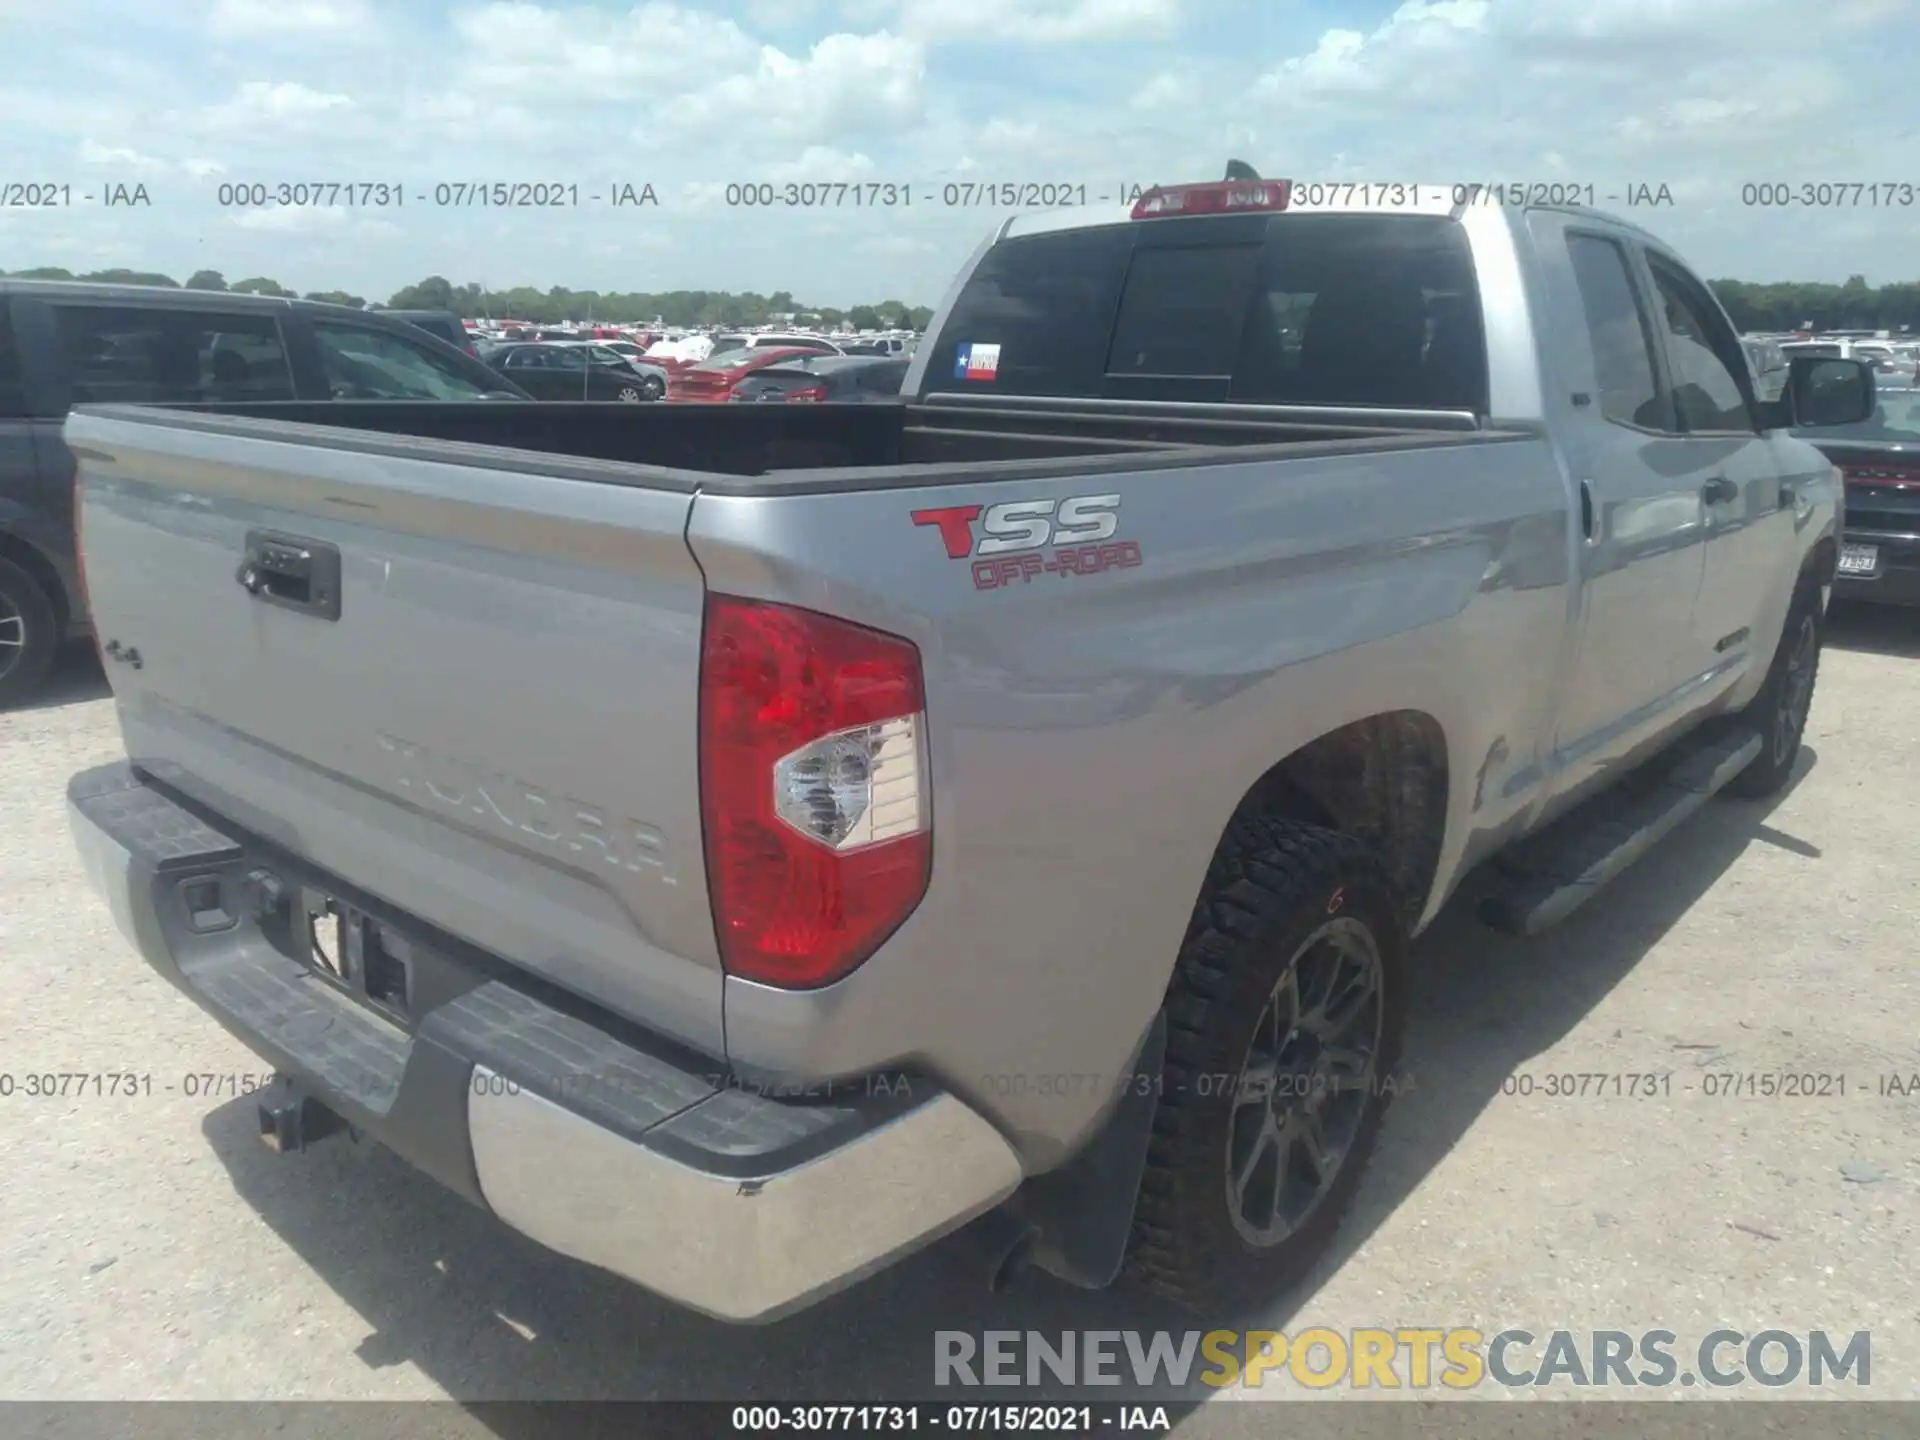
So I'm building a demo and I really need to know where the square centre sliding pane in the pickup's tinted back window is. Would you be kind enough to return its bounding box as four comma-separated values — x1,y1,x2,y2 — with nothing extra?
1106,246,1260,378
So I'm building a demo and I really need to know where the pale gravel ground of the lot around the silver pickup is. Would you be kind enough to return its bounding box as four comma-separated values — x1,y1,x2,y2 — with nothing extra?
0,612,1920,1440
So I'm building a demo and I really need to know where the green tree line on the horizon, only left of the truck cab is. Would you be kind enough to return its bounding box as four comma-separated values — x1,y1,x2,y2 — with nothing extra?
0,265,933,330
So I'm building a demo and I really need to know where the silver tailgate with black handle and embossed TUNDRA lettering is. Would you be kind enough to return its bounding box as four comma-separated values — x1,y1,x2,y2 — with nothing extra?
65,411,724,1056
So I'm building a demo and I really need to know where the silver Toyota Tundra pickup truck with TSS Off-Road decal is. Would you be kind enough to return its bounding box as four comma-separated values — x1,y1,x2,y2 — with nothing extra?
65,180,1872,1321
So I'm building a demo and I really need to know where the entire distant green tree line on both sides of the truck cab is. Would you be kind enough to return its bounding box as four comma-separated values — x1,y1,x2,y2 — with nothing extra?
12,265,1920,330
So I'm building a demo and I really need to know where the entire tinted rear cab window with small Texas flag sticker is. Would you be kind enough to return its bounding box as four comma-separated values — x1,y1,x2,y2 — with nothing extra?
925,213,1488,413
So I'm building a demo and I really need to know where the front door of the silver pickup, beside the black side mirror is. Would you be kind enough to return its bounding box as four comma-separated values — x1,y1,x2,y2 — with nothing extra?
1645,248,1795,687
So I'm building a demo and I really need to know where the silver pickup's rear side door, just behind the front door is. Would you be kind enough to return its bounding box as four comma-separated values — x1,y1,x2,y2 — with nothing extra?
1526,211,1705,793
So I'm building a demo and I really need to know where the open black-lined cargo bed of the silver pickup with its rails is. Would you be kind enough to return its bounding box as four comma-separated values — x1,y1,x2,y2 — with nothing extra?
77,397,1501,495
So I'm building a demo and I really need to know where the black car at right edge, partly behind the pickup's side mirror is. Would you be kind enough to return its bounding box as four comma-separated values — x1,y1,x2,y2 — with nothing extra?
1795,378,1920,605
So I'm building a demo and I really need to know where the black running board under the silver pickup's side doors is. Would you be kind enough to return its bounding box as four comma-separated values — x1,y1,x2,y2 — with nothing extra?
1478,730,1761,935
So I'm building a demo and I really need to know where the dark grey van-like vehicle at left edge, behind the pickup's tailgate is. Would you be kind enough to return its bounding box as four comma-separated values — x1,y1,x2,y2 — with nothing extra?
0,280,530,707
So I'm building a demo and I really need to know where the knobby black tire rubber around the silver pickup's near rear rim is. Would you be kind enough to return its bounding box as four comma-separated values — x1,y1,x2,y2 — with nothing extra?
1125,816,1407,1313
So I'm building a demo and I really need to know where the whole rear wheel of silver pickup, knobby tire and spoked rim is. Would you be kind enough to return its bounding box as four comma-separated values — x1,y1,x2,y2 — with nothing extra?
1127,818,1405,1308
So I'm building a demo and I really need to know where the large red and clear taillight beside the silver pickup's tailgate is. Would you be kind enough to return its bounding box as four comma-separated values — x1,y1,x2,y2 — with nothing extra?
699,595,933,989
